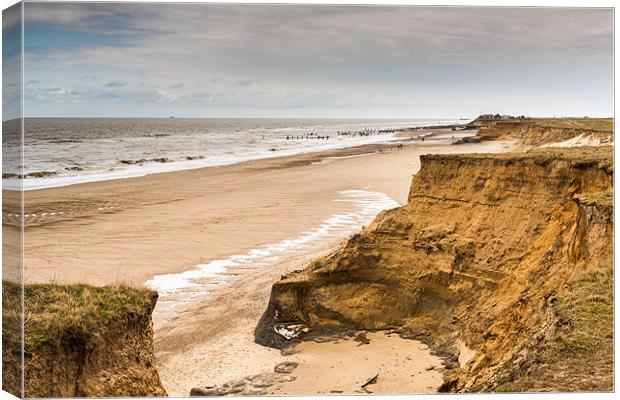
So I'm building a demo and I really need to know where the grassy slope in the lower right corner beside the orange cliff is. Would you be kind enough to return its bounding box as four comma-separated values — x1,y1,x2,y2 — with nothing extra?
499,266,614,392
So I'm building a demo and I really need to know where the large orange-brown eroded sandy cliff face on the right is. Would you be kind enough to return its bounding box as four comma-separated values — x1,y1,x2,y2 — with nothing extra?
257,148,613,391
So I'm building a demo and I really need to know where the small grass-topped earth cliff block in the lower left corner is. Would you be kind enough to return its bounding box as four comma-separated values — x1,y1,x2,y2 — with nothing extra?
2,281,166,398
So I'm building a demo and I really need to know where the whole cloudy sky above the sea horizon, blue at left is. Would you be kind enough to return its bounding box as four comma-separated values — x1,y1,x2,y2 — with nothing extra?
3,2,613,119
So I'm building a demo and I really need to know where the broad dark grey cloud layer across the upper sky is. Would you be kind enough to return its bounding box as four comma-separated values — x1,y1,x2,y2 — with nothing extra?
30,4,612,91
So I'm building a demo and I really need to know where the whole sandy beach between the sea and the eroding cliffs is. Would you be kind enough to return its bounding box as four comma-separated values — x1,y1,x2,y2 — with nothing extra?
15,130,513,396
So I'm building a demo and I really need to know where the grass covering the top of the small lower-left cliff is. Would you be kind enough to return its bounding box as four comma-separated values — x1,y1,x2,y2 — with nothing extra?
2,281,156,352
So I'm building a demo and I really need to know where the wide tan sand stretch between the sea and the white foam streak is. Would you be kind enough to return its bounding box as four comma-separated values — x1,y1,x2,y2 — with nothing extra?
20,126,503,285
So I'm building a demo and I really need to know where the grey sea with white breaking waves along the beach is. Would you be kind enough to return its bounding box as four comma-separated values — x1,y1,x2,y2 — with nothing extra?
2,118,463,190
